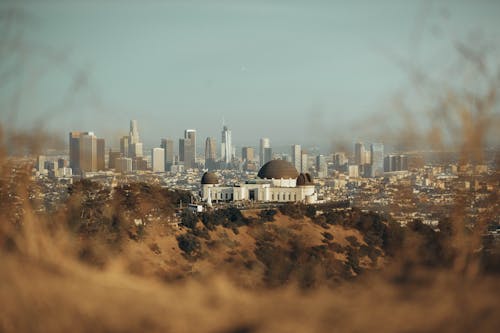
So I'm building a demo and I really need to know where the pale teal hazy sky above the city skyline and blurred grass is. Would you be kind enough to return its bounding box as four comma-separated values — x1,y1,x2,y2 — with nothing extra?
0,0,500,151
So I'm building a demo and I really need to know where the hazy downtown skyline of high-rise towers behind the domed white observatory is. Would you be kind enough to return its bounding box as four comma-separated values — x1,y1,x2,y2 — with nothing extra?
37,120,416,183
